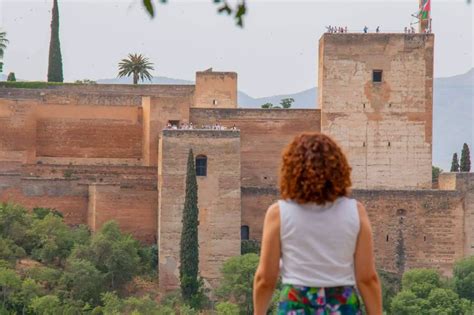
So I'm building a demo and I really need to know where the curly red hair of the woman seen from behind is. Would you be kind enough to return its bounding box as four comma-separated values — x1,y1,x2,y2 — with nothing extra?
280,133,351,204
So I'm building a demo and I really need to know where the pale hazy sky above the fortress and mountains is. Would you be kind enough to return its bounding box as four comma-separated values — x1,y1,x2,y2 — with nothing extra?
0,0,474,97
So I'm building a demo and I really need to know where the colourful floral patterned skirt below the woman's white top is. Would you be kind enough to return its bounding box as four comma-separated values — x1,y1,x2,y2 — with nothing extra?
278,284,362,315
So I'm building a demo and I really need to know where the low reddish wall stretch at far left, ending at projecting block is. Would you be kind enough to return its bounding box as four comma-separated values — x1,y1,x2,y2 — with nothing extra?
0,175,88,225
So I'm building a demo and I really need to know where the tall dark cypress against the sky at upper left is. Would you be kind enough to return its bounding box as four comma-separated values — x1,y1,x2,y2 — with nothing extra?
48,0,63,82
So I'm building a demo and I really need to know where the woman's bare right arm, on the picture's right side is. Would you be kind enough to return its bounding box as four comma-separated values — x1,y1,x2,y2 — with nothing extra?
354,203,382,315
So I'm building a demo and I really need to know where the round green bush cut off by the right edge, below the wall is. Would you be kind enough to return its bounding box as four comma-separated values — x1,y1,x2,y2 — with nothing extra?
453,256,474,302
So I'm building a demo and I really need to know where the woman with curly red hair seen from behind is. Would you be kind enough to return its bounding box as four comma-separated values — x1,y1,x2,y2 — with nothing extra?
254,133,382,315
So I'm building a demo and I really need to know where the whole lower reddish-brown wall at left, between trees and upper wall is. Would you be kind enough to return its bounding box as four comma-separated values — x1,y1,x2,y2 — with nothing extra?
0,164,158,239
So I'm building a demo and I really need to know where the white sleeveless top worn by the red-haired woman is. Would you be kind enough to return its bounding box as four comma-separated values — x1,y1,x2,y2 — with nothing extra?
278,197,360,287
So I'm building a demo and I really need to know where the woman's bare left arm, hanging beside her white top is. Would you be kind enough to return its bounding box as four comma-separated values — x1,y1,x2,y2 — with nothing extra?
253,204,280,315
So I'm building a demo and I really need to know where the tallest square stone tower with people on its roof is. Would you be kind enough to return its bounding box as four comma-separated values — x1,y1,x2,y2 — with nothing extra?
318,33,434,189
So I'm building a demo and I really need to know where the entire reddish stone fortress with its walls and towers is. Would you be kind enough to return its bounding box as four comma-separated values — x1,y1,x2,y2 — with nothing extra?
0,33,474,292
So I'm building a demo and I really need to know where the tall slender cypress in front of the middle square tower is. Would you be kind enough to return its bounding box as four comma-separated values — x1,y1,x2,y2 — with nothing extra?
179,149,201,307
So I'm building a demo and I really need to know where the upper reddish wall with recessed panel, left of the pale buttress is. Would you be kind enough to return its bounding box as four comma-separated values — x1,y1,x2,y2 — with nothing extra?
0,100,143,165
